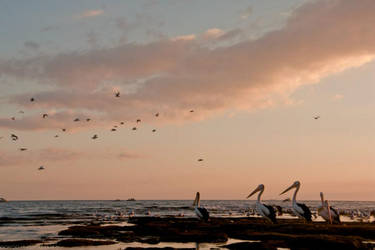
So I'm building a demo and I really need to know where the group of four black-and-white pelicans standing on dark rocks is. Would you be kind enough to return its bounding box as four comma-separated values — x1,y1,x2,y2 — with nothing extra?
193,181,341,224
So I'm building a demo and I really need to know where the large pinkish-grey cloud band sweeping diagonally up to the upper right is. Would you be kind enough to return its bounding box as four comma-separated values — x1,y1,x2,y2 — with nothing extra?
0,0,375,131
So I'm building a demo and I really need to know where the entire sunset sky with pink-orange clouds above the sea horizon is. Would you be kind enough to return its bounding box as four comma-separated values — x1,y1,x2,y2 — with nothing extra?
0,0,375,201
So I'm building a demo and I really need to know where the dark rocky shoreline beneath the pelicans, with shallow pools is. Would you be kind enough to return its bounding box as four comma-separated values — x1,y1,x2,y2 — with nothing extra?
0,217,375,249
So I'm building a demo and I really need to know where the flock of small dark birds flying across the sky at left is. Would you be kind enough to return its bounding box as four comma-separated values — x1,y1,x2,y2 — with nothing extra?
0,91,203,170
